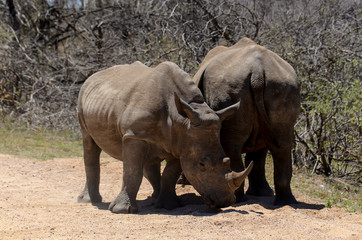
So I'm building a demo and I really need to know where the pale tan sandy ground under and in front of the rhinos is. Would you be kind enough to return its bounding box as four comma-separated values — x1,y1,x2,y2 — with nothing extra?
0,155,362,240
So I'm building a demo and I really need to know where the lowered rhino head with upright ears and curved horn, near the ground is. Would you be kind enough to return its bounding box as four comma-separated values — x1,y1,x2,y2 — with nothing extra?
175,95,253,208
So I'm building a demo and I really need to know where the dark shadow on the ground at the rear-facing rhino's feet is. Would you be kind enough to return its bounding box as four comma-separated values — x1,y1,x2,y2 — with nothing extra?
234,195,325,210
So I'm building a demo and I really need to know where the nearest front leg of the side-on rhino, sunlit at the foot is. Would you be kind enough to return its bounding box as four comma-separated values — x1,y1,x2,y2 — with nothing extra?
109,139,148,213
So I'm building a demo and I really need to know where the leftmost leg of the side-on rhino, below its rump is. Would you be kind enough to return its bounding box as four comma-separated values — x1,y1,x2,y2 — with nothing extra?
78,133,102,203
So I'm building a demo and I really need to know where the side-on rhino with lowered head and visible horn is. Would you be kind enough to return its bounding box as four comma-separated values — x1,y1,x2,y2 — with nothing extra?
78,62,251,213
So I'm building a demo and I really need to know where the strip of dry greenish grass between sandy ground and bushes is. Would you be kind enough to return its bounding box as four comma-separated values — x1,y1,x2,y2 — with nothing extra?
0,118,362,212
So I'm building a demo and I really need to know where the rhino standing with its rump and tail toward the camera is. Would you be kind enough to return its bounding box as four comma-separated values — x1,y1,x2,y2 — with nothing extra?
193,38,300,205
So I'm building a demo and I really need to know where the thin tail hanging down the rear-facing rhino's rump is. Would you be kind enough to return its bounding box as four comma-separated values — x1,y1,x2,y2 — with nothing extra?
250,71,278,147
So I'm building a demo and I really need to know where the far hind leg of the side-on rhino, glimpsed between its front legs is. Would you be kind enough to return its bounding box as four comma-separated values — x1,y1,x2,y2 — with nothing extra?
143,159,161,198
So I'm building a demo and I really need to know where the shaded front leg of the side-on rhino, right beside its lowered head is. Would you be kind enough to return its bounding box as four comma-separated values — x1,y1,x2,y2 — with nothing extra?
156,159,182,210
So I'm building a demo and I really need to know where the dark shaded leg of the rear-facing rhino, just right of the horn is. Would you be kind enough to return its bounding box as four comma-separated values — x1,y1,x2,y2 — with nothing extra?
245,148,274,196
